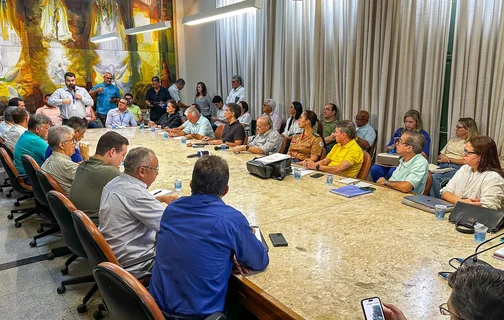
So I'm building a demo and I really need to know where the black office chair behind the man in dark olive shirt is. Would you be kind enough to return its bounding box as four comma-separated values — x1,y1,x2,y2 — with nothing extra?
47,190,94,294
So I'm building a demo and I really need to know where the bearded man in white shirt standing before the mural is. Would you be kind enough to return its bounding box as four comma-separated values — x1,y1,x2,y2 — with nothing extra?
47,72,94,124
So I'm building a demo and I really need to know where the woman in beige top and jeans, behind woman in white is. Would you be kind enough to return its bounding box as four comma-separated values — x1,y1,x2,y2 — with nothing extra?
430,118,479,198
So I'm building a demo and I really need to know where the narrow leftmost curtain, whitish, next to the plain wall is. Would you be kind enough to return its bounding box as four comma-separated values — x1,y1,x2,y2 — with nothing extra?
216,0,276,118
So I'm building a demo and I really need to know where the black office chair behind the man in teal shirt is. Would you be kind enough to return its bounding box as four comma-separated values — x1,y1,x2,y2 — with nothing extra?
21,154,60,247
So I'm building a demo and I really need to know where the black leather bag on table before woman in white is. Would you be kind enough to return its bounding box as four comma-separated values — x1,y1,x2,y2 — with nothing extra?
449,202,504,233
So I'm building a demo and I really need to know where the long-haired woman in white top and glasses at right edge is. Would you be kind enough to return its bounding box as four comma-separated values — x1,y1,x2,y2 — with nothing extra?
441,136,504,210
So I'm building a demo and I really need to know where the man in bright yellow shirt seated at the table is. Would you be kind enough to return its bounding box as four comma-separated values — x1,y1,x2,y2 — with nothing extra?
303,120,364,178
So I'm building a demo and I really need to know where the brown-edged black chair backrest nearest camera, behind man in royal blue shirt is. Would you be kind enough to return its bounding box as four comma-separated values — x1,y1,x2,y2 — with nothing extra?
93,262,165,320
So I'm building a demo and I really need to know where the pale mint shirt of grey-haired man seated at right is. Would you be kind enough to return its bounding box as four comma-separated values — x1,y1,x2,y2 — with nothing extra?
389,154,429,194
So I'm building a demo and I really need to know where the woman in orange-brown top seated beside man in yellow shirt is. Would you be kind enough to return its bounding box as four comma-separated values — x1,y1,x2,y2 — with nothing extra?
288,110,325,161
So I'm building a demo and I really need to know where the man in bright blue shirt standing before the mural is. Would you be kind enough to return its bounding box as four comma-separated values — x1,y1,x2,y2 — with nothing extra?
89,72,121,126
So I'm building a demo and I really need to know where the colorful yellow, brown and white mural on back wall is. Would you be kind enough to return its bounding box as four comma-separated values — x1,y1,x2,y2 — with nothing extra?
0,0,176,111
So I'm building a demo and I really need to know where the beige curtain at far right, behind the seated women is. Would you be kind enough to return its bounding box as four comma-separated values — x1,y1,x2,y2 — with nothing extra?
448,0,504,148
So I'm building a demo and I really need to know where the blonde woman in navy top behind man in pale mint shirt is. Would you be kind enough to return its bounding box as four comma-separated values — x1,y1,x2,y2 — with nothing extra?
371,110,430,182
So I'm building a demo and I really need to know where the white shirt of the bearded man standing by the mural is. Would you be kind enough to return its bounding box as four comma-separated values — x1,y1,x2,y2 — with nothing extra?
47,86,94,119
